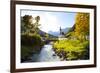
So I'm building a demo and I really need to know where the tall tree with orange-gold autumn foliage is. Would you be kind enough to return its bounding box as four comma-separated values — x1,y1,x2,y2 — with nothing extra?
74,13,89,40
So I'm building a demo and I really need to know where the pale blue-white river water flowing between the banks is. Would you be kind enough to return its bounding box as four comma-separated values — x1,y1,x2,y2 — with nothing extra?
32,44,60,62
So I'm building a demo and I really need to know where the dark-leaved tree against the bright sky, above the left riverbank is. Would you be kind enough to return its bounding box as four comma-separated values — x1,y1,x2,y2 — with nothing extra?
21,15,40,34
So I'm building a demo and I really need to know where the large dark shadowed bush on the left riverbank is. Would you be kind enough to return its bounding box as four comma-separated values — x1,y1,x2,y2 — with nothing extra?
21,34,43,62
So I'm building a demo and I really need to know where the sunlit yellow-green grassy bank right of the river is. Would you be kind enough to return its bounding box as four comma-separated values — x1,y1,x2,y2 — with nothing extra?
53,40,89,60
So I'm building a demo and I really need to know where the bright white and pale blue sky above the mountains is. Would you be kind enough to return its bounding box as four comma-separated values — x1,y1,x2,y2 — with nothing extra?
21,10,76,33
